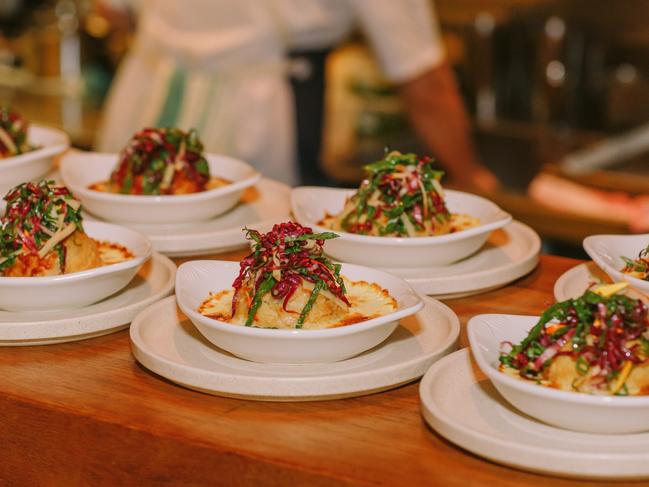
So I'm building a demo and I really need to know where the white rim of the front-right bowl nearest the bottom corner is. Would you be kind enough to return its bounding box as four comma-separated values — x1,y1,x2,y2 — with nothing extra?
467,313,649,408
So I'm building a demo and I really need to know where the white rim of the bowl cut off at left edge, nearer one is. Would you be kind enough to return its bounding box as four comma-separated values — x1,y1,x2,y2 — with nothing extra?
0,221,153,288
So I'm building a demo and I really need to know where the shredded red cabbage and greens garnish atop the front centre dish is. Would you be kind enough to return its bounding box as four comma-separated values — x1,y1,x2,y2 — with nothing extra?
232,222,350,328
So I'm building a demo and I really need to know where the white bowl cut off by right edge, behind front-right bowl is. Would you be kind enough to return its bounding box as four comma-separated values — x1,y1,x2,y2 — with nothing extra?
584,233,649,294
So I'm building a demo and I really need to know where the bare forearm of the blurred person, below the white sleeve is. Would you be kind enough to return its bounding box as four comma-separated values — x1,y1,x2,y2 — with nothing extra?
399,61,498,190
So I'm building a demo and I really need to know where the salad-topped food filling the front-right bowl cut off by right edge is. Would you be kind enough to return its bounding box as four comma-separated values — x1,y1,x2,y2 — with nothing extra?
500,286,649,395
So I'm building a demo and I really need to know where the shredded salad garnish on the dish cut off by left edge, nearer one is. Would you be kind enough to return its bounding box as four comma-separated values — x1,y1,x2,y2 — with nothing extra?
0,181,82,271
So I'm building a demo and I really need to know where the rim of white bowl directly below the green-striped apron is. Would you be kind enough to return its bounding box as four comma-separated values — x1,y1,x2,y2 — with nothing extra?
59,151,261,205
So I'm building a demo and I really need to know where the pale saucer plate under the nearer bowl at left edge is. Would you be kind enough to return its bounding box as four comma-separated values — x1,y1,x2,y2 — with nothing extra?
0,254,176,346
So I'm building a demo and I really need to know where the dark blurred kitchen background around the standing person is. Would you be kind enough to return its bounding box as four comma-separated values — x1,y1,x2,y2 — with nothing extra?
0,0,649,256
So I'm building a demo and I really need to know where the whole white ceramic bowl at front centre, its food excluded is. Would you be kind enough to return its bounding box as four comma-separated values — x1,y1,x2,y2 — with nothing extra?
176,260,423,364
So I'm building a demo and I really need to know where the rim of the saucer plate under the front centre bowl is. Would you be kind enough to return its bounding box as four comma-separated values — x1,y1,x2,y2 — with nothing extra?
129,296,460,402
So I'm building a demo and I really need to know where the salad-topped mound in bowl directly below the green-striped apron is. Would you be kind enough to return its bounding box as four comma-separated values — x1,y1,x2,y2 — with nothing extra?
110,128,210,195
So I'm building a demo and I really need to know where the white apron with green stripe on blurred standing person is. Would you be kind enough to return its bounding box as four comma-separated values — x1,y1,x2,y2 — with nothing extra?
97,0,296,184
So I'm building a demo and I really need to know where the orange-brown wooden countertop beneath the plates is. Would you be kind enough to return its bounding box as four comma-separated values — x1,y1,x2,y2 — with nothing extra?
0,253,640,486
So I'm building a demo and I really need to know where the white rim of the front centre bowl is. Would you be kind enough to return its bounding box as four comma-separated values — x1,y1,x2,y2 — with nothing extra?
176,260,424,340
